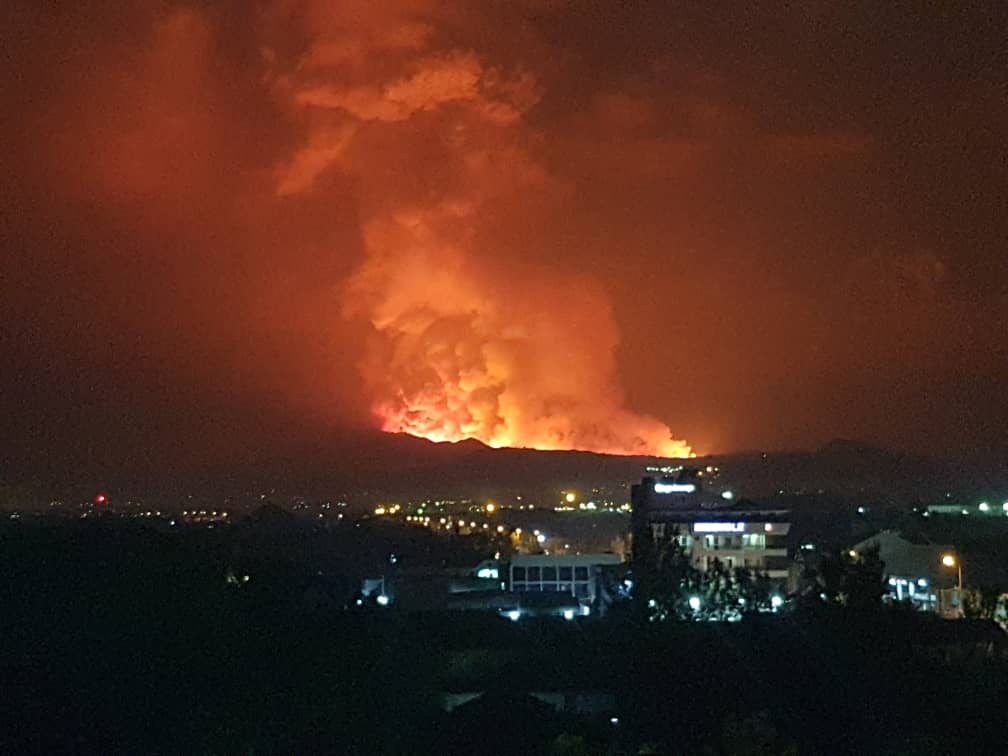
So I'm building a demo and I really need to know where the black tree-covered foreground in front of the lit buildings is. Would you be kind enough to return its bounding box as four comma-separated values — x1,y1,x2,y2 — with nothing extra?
0,523,1008,755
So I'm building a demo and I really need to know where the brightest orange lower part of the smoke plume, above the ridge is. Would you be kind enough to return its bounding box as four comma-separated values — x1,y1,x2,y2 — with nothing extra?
349,209,690,457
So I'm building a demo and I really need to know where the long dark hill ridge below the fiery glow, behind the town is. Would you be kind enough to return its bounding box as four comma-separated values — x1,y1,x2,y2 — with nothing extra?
0,431,1008,507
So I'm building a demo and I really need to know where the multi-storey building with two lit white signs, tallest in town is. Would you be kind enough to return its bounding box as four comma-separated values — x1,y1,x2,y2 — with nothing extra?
631,468,790,584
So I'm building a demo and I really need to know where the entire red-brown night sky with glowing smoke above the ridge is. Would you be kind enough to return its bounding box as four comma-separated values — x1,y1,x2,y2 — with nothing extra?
0,0,1008,477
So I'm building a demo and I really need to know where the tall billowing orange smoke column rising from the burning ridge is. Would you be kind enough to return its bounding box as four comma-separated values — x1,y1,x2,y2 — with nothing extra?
266,4,690,457
